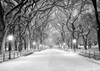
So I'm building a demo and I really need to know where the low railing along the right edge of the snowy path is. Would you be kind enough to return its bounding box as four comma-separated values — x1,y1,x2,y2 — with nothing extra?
79,50,100,60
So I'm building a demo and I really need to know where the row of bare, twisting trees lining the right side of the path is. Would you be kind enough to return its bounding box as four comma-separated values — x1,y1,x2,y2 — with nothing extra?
45,0,97,49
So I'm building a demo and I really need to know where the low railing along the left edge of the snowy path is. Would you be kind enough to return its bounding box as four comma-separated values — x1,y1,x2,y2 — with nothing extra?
0,51,33,63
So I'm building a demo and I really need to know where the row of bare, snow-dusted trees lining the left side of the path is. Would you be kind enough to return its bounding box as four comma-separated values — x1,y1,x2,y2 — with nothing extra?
0,0,52,52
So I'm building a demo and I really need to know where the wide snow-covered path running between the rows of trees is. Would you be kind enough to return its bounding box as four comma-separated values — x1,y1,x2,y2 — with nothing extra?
0,49,100,71
